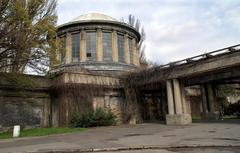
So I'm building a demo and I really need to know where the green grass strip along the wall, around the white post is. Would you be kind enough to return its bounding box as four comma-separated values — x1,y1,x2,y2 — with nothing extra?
0,128,86,139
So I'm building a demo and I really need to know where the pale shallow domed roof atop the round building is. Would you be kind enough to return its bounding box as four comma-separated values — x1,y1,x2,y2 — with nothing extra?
71,13,118,22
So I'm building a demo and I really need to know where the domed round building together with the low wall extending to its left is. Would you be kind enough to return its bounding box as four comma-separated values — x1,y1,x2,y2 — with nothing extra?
0,13,145,127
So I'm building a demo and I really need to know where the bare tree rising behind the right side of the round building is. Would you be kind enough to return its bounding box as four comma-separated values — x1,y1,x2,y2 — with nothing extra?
127,14,148,67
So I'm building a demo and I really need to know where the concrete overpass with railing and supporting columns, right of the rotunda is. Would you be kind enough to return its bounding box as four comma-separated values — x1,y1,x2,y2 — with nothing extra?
131,44,240,124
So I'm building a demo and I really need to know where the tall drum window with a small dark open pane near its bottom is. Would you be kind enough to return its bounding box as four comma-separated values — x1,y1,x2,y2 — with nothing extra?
86,32,96,60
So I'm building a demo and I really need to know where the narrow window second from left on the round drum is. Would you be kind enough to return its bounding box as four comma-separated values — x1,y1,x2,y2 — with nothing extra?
72,33,80,62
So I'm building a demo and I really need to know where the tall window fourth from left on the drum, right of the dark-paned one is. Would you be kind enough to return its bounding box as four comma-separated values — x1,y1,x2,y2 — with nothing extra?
103,32,112,61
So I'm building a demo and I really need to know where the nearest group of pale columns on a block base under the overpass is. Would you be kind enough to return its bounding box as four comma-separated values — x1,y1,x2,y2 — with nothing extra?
166,79,192,125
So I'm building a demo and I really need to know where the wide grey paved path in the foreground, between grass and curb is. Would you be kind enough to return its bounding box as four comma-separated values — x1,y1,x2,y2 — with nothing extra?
0,122,240,153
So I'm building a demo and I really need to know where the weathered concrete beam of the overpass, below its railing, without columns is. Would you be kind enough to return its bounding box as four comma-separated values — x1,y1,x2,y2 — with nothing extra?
133,51,240,85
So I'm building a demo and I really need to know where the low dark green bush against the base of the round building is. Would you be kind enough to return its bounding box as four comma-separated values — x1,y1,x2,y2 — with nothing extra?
69,108,116,128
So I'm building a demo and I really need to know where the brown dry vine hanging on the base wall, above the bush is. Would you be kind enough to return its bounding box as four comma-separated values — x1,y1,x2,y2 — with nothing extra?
52,74,109,126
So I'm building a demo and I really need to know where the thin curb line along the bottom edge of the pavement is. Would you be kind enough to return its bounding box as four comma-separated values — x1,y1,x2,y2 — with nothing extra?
26,145,240,153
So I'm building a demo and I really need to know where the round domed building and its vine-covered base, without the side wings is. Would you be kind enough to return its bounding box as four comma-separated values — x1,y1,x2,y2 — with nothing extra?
51,13,141,126
